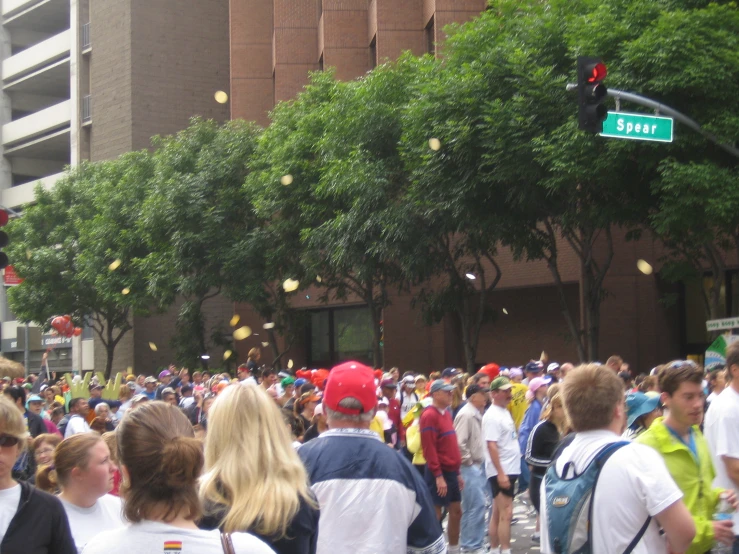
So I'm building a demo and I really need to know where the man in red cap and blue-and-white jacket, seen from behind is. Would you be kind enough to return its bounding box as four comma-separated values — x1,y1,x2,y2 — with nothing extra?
298,361,446,554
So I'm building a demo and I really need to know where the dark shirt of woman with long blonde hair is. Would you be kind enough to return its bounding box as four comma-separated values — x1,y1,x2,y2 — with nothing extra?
201,492,321,554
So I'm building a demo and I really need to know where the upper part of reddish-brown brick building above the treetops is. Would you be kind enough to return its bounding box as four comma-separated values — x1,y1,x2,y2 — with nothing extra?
230,0,487,125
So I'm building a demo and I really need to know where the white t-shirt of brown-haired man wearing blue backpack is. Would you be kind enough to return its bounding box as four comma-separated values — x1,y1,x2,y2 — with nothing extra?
540,431,683,554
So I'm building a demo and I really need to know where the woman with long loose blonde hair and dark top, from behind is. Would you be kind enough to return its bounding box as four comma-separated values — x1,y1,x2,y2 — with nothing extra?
200,386,319,554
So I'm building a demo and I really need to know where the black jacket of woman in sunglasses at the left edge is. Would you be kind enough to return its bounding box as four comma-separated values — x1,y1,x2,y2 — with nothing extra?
0,483,77,554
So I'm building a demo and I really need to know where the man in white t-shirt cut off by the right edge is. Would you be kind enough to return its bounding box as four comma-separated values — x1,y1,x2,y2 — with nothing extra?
704,341,739,554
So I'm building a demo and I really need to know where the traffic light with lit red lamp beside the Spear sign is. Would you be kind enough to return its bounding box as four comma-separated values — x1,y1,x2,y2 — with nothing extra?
577,56,608,134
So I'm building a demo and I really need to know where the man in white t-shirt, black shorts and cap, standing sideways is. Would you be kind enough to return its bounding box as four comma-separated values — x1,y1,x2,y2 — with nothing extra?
482,377,521,554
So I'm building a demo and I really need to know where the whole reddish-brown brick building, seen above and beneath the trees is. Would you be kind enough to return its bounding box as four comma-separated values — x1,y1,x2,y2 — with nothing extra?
225,0,692,371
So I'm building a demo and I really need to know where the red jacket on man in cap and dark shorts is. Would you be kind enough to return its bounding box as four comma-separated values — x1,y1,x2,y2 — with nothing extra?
420,406,462,477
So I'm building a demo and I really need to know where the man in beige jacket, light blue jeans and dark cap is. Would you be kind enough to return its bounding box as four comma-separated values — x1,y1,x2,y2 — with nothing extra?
454,382,489,554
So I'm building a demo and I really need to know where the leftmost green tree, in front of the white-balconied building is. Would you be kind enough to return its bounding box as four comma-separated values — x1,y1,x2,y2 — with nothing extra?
8,152,156,379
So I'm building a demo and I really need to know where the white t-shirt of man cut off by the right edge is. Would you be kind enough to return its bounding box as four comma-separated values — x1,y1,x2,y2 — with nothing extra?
703,386,739,535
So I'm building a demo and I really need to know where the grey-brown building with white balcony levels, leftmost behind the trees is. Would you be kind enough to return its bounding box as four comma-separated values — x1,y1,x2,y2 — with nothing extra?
0,0,231,370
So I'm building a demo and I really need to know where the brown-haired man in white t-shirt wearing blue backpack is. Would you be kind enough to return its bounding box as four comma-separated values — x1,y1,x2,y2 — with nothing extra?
540,364,695,554
